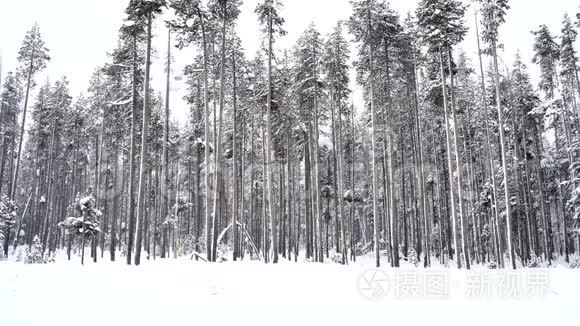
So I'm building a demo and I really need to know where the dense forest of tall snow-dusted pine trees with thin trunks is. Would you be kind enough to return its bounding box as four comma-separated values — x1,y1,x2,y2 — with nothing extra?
0,0,580,273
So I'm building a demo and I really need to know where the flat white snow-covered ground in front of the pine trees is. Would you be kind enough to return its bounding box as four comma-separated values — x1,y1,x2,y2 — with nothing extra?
0,252,580,326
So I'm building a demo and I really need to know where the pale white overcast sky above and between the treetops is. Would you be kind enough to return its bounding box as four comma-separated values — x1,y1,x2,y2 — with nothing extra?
0,0,579,122
